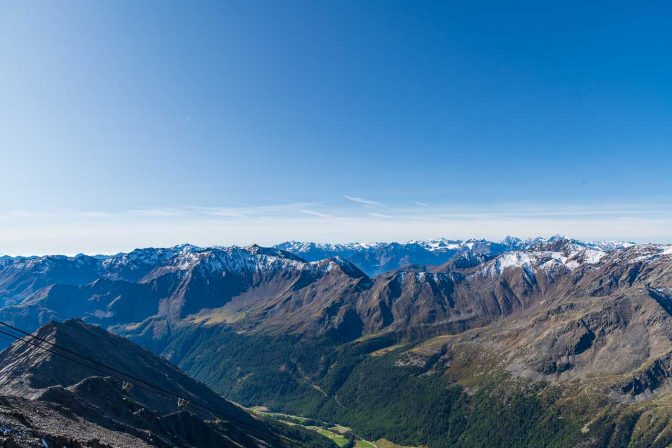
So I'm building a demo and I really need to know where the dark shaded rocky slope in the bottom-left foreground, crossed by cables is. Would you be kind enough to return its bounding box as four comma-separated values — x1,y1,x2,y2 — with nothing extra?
0,320,310,447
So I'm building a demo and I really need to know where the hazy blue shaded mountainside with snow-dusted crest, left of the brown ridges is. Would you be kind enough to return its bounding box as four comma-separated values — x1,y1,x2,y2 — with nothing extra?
0,246,378,344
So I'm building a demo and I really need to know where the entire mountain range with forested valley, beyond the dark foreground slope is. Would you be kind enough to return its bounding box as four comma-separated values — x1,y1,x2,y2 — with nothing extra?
0,237,672,447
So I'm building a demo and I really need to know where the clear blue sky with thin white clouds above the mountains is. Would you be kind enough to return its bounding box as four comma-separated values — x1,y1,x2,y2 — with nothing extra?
0,1,672,253
